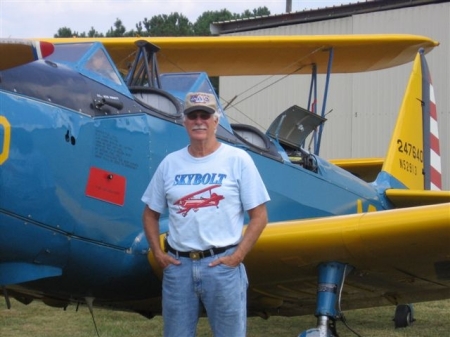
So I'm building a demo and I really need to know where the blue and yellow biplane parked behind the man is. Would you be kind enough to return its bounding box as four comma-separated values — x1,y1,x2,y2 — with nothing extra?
0,35,450,336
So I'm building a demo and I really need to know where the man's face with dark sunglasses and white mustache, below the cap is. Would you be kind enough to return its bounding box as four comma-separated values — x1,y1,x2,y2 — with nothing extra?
184,110,219,140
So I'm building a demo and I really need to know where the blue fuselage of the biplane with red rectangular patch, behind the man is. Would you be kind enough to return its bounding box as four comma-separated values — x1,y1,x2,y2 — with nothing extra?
0,41,386,312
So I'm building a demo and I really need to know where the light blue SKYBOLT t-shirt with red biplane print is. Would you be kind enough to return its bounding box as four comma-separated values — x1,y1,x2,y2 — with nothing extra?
142,144,270,251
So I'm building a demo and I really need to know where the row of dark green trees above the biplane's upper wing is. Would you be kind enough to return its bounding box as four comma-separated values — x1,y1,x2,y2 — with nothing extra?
54,6,270,38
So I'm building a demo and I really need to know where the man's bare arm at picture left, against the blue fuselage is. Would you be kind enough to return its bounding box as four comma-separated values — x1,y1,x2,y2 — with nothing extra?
142,205,180,268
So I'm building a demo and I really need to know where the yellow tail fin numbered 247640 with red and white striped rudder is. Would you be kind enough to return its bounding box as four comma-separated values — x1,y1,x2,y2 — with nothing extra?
381,51,442,190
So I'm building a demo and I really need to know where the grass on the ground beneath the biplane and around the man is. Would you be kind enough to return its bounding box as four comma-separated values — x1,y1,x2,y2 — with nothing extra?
0,300,450,337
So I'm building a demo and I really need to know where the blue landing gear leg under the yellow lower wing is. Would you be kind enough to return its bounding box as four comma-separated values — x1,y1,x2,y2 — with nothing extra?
299,262,352,337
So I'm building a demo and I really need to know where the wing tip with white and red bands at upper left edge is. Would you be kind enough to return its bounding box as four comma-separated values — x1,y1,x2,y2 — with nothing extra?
0,39,54,71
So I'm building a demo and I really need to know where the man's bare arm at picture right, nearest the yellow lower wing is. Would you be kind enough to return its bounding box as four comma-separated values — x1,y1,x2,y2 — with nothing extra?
210,204,267,267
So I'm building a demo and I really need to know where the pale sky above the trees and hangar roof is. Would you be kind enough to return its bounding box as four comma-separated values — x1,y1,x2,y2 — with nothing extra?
0,0,358,38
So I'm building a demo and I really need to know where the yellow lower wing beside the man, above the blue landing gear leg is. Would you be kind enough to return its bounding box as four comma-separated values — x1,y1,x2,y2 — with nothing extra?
245,204,450,316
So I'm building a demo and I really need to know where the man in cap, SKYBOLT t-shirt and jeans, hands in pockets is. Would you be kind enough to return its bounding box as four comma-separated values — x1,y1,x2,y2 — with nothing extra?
142,93,270,337
